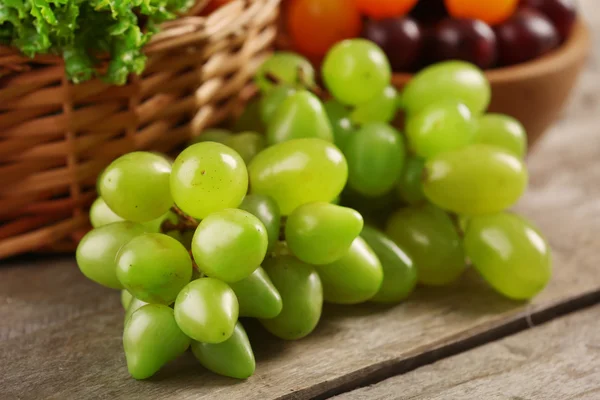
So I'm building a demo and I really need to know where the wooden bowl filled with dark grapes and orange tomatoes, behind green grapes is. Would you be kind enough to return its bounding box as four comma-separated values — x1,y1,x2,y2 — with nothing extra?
279,0,590,144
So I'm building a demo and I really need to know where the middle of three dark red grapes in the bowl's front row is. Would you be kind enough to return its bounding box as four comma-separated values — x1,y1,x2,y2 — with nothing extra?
427,18,497,68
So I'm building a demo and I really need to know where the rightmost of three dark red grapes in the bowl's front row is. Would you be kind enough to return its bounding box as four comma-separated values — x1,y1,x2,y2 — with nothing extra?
495,8,560,65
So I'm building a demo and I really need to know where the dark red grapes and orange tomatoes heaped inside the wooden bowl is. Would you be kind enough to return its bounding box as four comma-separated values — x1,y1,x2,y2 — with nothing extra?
286,0,576,72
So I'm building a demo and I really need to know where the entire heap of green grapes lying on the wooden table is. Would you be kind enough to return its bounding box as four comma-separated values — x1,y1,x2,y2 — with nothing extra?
77,39,551,379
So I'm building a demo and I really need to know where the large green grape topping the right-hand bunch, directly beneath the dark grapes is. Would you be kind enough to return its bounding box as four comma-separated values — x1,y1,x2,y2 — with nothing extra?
402,61,491,115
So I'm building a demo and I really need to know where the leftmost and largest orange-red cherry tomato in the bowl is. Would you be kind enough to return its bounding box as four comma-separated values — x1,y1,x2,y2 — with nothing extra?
287,0,362,57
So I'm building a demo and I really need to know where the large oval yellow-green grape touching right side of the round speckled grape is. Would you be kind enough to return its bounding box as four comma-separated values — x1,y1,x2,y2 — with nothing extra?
248,139,348,215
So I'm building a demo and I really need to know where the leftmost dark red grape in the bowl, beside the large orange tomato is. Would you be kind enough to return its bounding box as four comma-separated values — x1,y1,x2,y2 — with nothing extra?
362,17,423,72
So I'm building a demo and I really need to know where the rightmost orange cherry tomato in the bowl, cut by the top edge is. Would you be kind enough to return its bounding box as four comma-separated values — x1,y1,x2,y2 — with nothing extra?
445,0,519,25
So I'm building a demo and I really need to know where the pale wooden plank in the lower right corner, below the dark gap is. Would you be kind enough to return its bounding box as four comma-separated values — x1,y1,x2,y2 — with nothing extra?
334,306,600,400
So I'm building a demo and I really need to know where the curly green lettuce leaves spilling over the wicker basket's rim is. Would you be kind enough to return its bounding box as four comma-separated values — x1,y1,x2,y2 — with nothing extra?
0,0,194,85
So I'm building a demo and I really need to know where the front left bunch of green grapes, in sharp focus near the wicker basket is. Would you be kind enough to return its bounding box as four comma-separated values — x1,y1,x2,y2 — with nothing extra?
76,101,392,379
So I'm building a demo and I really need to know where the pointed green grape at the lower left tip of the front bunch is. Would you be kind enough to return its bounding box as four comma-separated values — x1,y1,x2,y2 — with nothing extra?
123,304,190,379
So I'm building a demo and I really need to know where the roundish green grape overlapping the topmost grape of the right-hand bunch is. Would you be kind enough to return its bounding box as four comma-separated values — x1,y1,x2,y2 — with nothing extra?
406,101,476,158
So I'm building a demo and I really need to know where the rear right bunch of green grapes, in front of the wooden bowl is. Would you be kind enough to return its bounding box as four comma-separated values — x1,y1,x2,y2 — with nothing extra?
251,43,551,303
